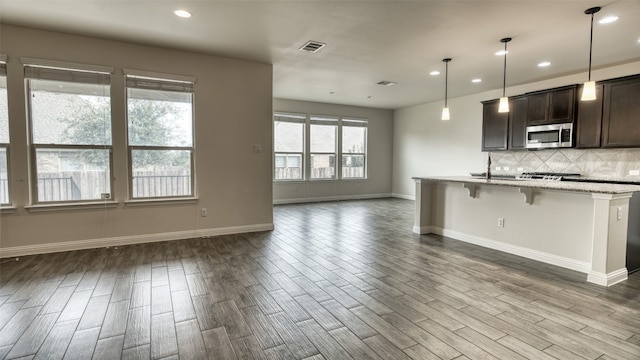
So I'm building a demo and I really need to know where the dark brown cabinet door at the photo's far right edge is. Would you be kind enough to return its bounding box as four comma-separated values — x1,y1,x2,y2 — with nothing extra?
602,77,640,147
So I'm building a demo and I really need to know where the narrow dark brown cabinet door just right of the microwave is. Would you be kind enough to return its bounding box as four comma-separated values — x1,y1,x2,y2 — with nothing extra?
576,85,604,149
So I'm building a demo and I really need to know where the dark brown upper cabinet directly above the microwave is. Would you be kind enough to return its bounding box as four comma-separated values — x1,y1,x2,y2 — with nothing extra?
527,85,577,125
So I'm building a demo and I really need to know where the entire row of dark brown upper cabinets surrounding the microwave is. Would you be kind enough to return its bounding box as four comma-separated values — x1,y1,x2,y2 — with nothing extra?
482,74,640,151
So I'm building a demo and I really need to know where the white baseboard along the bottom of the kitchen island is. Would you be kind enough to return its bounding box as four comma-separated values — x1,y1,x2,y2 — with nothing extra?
431,227,592,274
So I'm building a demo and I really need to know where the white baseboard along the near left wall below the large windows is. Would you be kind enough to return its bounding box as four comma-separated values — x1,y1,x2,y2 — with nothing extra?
0,223,273,258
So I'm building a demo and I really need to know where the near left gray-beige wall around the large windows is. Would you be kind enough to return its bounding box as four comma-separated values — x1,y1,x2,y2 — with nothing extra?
0,24,273,256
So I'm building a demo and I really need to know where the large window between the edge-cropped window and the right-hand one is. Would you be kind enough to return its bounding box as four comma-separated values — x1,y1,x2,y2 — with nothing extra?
25,65,112,203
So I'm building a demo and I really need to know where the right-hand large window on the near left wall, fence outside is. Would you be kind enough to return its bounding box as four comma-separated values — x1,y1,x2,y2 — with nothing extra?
126,75,194,199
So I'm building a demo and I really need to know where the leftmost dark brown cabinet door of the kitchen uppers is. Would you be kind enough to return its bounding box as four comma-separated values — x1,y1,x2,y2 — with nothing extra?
482,100,509,151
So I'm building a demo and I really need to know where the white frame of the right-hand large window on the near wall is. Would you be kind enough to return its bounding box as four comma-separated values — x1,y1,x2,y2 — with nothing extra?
123,69,197,201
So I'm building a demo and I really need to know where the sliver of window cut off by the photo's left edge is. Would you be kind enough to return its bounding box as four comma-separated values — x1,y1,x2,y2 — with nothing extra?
0,60,11,205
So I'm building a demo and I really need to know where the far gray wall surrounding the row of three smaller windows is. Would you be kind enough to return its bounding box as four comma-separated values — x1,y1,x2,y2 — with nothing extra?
273,99,393,204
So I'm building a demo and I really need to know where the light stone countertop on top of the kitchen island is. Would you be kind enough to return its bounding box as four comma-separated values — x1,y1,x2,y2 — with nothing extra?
413,176,640,194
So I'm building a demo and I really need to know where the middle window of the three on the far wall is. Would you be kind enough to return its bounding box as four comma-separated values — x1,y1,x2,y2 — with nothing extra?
309,116,338,180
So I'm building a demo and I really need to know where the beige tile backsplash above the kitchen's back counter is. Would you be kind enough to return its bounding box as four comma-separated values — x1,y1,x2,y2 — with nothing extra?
491,149,640,180
